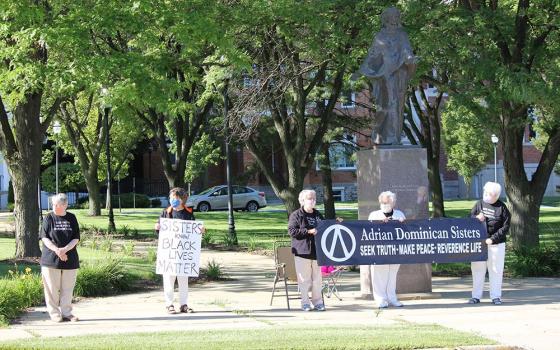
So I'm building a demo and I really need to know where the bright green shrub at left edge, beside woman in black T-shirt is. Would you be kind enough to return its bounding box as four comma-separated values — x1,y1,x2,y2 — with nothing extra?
0,266,43,325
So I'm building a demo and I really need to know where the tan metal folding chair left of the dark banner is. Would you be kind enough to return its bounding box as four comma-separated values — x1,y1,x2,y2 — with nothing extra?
270,241,300,310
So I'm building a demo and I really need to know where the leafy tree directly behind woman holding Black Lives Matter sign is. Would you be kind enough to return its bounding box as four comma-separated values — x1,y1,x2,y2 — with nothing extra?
93,0,232,187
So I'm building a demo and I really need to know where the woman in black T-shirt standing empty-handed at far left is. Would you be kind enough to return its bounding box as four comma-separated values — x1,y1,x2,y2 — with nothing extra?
40,193,80,322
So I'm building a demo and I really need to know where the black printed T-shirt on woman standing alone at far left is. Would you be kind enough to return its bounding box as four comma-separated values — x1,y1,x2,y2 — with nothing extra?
40,212,80,270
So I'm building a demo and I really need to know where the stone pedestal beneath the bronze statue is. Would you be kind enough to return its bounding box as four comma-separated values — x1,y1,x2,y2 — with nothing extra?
357,146,432,298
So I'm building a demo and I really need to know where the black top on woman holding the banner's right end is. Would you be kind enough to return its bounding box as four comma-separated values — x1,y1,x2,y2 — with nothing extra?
471,200,511,244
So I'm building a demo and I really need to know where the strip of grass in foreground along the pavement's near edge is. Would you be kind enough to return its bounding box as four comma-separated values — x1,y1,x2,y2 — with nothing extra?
0,323,495,350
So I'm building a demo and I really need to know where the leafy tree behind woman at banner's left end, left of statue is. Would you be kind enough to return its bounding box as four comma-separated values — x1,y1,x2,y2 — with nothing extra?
230,1,384,213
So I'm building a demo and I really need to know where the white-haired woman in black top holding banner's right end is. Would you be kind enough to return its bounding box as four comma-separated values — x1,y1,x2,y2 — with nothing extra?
469,182,511,305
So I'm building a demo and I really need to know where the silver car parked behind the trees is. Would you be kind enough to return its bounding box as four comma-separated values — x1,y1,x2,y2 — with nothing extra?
187,185,266,212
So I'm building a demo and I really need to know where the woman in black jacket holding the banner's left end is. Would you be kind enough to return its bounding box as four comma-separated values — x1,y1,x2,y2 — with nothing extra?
288,190,325,311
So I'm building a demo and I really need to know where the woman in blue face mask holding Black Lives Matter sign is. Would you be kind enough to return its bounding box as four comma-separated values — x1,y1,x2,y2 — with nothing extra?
155,187,204,314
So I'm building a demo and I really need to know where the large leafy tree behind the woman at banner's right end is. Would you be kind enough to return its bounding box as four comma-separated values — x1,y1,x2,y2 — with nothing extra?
403,0,560,248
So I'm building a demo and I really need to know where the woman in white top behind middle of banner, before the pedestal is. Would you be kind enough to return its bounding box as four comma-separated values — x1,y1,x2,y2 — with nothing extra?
368,191,406,309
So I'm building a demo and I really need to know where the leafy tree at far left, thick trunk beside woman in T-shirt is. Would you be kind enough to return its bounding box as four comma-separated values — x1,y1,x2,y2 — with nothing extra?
0,0,84,257
